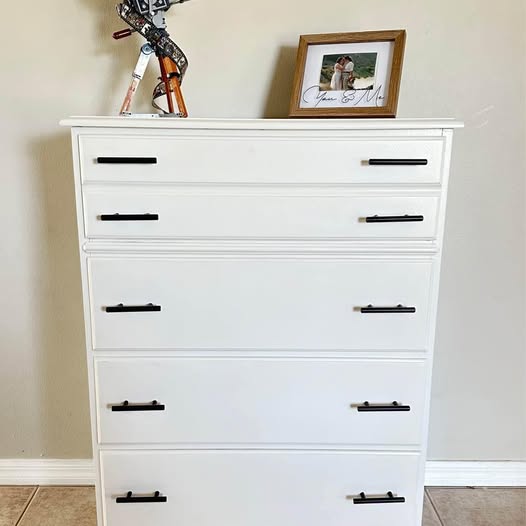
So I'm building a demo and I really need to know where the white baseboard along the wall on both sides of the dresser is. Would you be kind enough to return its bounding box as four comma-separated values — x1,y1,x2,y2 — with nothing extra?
0,459,526,486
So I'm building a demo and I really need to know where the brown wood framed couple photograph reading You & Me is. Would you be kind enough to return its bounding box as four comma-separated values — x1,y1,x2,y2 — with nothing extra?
289,30,406,117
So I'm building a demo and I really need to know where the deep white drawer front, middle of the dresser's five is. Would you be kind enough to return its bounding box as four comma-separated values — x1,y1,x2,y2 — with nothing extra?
89,256,433,350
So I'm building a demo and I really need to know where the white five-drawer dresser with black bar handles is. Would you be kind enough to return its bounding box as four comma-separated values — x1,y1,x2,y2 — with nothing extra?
63,118,461,526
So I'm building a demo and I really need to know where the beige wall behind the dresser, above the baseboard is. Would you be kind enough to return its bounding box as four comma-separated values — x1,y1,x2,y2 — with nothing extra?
0,0,526,460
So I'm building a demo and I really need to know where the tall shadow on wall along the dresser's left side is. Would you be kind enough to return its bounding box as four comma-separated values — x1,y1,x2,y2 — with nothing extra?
28,134,91,458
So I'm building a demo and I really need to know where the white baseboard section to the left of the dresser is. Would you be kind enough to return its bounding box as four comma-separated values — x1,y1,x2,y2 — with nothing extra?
0,458,95,486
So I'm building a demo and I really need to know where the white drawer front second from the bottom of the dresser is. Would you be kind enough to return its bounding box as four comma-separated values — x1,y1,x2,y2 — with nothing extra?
96,358,425,447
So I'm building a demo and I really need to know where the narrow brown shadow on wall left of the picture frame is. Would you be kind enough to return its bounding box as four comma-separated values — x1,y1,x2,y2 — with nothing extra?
263,46,298,119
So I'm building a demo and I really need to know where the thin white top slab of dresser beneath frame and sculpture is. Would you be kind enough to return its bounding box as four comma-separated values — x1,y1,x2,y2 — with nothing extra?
60,116,464,130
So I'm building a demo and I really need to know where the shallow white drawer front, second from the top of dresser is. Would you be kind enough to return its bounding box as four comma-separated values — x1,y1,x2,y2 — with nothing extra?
84,187,439,239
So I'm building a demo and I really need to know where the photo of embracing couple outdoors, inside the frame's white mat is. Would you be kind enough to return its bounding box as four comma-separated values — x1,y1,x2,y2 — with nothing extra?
320,53,377,91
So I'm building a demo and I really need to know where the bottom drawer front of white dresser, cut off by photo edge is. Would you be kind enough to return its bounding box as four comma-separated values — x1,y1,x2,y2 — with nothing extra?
101,451,420,526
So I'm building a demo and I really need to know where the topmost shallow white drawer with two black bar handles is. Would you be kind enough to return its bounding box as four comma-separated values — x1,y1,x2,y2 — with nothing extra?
79,135,444,185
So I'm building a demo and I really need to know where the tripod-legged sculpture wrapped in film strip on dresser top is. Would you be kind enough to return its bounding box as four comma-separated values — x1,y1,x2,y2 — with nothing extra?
113,0,188,117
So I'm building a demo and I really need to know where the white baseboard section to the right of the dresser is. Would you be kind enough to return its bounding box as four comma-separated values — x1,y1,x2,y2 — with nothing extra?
425,461,526,486
